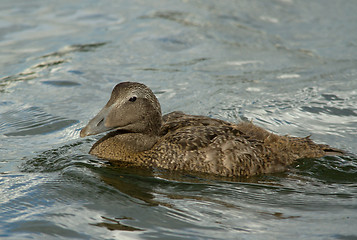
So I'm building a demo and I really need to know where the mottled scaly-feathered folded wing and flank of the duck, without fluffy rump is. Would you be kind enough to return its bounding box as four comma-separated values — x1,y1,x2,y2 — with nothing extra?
154,115,265,176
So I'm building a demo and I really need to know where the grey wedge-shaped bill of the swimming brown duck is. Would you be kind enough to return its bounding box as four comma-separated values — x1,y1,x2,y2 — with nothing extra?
80,107,113,137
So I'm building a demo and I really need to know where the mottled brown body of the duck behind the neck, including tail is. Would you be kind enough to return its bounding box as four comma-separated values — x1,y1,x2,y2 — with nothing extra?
155,112,339,176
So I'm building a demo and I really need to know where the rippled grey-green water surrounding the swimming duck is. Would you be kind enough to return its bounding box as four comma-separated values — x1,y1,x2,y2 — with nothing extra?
0,0,357,240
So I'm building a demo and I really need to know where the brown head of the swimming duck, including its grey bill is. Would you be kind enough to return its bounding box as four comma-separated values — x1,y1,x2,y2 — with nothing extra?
80,82,162,137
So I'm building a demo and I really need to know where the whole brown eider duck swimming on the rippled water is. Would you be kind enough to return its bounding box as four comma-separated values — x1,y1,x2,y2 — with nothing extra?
80,82,342,177
